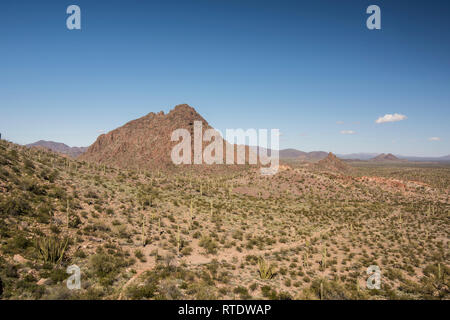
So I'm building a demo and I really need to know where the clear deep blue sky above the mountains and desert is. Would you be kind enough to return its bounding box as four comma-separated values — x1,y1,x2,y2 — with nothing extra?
0,0,450,156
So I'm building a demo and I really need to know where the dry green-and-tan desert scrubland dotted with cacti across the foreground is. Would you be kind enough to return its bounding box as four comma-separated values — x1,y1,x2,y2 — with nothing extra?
0,141,450,299
